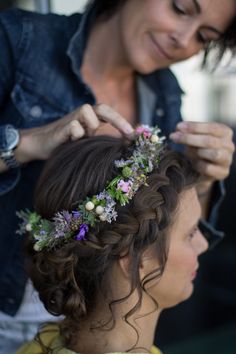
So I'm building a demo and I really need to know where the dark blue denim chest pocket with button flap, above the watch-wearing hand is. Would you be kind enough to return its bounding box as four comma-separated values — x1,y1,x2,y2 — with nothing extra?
11,79,67,128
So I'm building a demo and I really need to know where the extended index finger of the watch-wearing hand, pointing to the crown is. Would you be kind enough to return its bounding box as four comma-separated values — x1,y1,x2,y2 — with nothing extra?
94,103,134,138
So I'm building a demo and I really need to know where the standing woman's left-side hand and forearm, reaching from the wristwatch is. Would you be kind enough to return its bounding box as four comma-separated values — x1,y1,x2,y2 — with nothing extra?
15,104,133,163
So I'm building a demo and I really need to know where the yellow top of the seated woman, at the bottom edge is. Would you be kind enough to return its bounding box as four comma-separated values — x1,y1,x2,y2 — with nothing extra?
15,324,162,354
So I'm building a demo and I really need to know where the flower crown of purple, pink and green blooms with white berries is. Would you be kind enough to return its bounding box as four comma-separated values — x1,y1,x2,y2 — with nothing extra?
17,125,165,251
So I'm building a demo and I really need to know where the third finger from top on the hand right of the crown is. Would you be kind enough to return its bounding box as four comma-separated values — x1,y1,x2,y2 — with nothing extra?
196,149,233,166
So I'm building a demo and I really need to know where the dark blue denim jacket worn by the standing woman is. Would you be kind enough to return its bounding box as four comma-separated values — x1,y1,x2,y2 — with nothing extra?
0,9,224,316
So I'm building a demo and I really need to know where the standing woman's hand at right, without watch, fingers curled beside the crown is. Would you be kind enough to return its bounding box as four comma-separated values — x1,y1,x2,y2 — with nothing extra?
170,122,235,193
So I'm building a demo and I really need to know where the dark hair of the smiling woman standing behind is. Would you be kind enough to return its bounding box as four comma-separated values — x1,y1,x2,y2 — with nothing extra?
87,0,236,68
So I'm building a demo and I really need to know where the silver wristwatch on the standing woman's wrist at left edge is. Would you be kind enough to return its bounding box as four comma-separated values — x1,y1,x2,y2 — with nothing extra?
0,124,20,168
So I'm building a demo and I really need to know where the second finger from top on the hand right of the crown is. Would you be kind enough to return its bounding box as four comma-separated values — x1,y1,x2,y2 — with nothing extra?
169,132,234,151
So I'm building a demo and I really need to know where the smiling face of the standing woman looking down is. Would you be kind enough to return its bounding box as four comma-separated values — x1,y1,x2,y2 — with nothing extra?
120,0,236,73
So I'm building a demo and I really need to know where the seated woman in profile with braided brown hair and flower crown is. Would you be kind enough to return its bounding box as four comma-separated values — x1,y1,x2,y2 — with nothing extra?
18,127,208,354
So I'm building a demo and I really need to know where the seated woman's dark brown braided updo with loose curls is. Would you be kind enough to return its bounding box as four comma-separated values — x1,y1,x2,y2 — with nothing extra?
28,136,198,345
